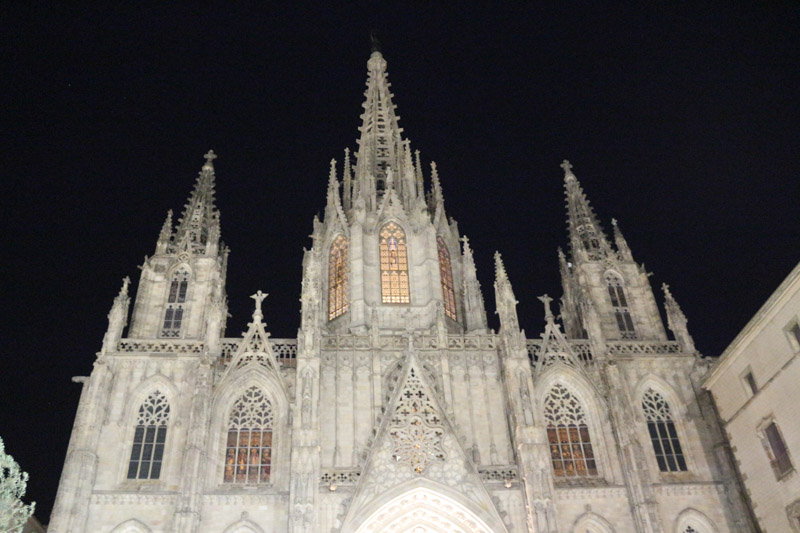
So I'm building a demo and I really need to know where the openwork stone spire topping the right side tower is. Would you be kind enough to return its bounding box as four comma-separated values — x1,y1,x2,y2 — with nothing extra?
561,159,611,261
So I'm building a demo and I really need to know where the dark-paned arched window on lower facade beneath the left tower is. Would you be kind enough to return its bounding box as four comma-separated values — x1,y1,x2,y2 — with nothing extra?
128,391,169,479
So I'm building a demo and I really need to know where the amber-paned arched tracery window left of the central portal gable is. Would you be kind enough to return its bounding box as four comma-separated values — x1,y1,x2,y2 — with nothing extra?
224,386,273,483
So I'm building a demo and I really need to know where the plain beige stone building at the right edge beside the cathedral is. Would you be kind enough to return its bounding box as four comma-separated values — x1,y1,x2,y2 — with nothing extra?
703,264,800,532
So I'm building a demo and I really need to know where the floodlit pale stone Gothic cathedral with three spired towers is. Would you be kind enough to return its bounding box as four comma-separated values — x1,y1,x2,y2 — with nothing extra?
48,51,756,533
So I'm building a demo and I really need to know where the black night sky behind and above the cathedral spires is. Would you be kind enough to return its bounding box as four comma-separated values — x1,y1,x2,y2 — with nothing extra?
0,2,800,522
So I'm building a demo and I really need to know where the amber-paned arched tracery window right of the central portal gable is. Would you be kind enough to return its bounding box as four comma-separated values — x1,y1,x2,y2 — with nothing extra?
544,383,597,477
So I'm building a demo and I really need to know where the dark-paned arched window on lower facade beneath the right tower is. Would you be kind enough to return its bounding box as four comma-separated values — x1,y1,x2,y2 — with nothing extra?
642,389,686,472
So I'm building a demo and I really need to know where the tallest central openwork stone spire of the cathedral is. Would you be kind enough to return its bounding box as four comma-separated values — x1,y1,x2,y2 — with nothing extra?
356,50,404,200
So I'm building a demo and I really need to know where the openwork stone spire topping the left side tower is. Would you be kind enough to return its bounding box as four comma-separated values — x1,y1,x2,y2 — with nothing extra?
175,150,219,254
